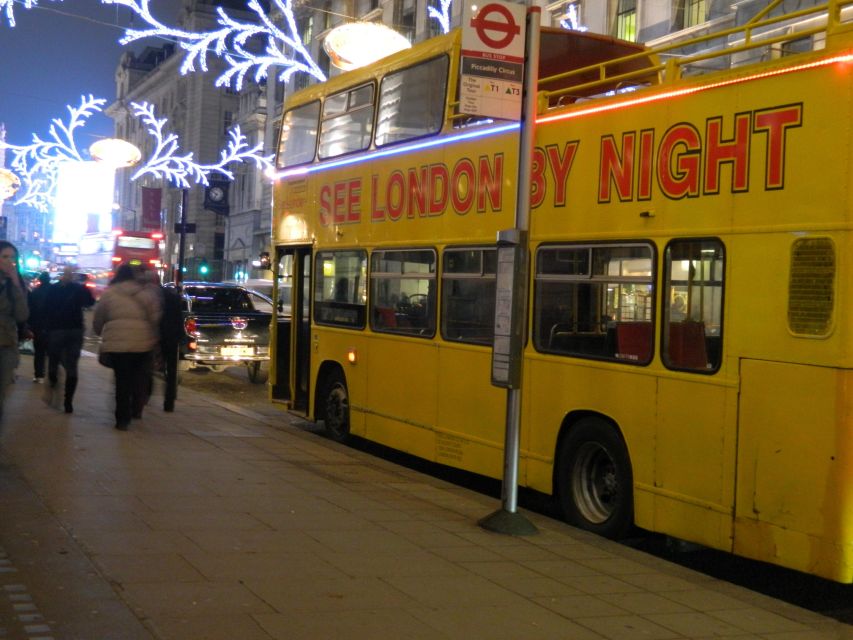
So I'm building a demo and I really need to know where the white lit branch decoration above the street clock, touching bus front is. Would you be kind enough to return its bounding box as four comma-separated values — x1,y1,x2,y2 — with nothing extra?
131,102,273,189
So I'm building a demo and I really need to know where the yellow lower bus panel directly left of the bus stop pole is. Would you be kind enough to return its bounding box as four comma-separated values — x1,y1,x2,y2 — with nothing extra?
435,343,506,478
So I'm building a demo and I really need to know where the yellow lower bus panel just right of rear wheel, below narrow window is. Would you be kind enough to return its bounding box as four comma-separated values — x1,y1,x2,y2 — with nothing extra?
653,372,737,551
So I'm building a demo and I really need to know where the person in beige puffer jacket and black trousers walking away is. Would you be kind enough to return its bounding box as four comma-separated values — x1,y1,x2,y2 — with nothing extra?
92,264,162,430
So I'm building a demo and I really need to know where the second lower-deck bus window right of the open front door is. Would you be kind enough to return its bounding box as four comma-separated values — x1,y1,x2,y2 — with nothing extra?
370,249,436,337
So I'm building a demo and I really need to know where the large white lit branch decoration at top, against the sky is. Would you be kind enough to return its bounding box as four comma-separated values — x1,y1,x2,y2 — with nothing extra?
101,0,326,90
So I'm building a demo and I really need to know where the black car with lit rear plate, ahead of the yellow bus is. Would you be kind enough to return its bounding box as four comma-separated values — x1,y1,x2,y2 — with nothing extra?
166,282,273,382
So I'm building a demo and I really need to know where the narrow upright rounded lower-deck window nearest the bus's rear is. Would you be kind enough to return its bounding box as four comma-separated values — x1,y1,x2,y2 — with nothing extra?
661,239,724,373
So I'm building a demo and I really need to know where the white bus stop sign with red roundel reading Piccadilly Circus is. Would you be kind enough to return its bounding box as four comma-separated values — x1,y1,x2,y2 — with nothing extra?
460,1,526,120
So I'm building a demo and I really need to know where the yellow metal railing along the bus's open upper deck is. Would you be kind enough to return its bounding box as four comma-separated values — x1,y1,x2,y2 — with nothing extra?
539,0,853,113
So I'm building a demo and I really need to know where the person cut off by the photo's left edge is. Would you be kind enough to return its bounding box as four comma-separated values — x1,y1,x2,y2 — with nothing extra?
0,240,29,419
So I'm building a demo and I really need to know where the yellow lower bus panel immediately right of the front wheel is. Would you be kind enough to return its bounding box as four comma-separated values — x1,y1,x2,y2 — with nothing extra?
366,334,439,460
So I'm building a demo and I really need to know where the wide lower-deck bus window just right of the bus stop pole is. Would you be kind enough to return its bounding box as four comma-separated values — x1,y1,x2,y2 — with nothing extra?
533,244,654,364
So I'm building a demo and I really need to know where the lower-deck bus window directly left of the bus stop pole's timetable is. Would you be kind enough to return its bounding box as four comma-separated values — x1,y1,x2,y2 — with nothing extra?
441,249,497,345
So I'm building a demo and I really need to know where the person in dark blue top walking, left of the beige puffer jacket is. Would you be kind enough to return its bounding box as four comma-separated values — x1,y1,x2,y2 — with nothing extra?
45,266,95,413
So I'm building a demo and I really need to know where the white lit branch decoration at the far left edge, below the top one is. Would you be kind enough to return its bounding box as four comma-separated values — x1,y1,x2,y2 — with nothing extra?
0,95,107,212
